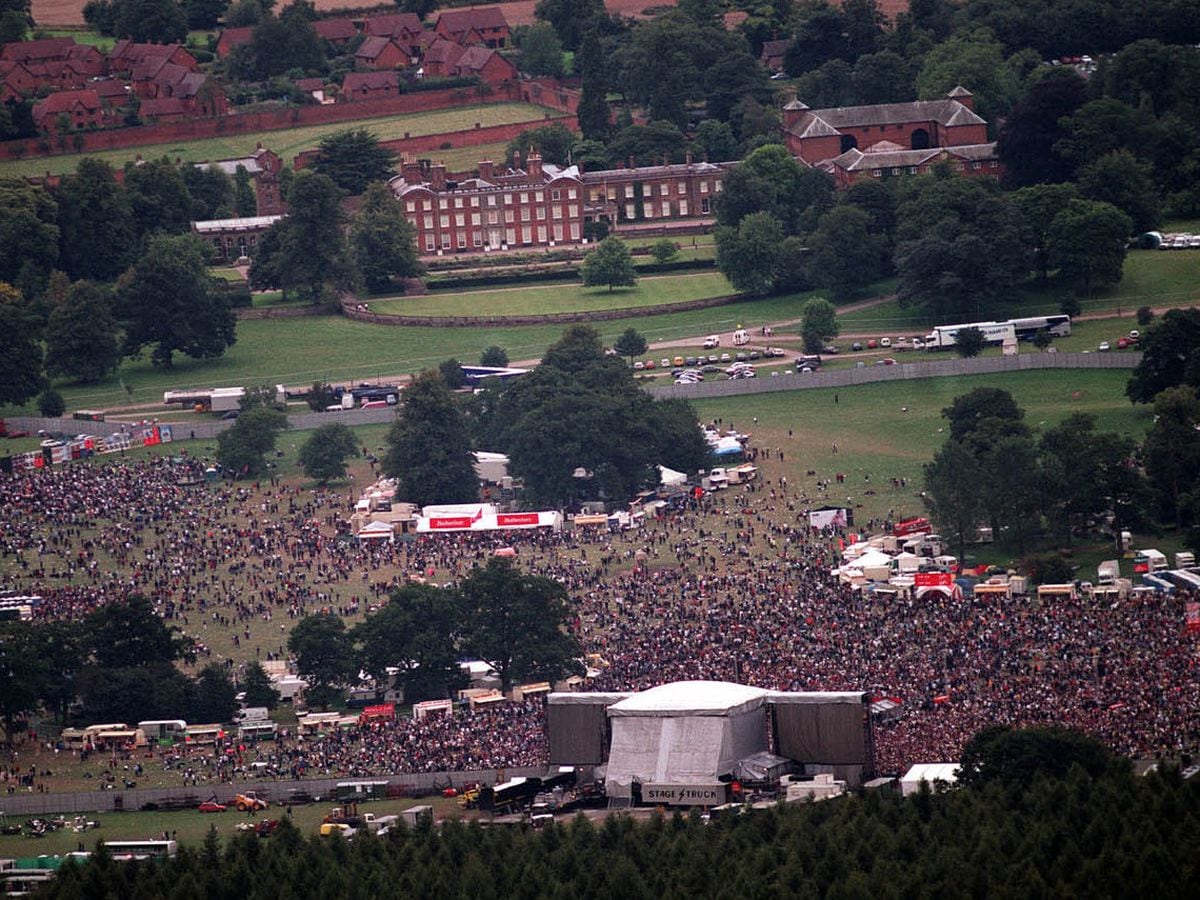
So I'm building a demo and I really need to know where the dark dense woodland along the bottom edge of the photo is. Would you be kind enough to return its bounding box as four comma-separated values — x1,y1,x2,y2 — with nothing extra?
35,730,1200,900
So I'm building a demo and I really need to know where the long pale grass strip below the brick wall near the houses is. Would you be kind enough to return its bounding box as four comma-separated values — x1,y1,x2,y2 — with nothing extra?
0,103,564,178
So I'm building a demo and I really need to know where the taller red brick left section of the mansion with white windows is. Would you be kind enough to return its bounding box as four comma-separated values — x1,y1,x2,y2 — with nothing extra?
389,155,583,256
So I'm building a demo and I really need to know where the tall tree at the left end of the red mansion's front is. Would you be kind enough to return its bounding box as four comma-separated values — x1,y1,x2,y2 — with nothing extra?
349,182,425,290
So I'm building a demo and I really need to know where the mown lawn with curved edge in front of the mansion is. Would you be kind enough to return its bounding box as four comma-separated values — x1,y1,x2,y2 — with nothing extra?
371,272,733,319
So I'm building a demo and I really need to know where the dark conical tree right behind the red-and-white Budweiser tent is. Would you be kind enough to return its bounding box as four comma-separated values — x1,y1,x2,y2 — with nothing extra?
383,371,479,506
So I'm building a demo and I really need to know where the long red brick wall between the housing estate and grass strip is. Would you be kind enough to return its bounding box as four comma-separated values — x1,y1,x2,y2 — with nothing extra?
0,84,537,160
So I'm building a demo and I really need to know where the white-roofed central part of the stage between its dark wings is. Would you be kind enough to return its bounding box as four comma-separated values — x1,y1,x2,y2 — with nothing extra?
607,682,767,798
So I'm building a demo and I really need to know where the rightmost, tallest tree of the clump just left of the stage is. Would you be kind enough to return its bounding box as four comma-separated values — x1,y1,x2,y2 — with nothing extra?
458,557,582,691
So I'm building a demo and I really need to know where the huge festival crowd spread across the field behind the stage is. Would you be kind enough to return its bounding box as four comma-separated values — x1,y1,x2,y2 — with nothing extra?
0,454,1200,782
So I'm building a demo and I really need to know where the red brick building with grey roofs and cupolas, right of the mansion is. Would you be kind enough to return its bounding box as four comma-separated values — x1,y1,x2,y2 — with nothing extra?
784,86,1000,186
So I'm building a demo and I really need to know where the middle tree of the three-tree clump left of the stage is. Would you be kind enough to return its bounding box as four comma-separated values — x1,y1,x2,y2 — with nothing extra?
352,584,464,703
